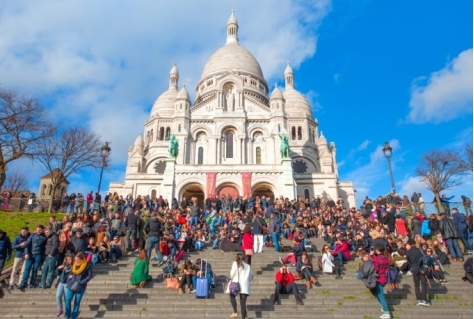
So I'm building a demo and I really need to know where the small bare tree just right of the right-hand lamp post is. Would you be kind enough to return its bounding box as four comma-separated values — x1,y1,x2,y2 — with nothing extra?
416,150,463,212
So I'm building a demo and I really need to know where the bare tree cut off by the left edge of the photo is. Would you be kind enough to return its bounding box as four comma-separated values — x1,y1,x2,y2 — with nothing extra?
0,87,56,188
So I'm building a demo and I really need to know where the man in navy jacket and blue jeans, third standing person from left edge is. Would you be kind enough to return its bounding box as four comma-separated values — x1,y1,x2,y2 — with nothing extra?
18,225,47,291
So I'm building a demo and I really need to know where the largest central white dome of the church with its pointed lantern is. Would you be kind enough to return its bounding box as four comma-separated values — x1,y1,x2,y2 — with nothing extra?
201,13,265,82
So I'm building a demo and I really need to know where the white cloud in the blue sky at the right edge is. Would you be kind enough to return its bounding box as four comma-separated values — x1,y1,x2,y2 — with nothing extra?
407,49,473,124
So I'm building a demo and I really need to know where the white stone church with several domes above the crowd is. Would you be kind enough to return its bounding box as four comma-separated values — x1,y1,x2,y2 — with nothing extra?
109,14,355,207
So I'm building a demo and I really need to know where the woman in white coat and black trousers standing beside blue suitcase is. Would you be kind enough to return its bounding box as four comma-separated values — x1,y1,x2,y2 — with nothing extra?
225,253,252,319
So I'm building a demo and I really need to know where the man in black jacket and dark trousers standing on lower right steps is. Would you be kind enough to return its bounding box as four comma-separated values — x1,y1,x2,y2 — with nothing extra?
406,239,431,307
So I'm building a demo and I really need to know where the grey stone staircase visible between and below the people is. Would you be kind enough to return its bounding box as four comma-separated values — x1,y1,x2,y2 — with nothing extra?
0,239,473,319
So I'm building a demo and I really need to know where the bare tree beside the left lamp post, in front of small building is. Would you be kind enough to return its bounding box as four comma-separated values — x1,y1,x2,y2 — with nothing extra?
35,127,102,212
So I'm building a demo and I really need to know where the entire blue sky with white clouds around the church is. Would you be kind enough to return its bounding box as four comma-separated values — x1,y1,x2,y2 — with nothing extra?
0,0,473,208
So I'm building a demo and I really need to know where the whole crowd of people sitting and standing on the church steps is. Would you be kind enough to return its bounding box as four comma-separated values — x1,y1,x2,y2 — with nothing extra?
0,192,472,318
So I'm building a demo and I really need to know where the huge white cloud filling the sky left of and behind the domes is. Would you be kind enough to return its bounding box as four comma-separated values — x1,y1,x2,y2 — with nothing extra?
0,0,331,171
